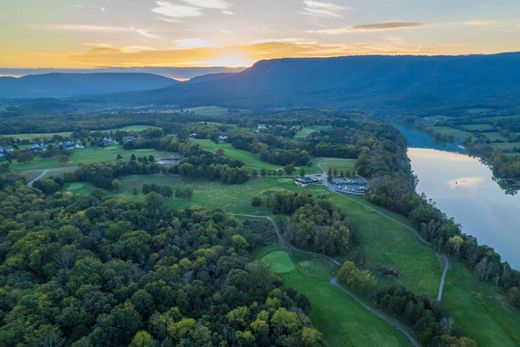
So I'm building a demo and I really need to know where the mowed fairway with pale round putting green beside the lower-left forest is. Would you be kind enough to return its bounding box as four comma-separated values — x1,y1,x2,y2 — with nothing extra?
258,246,410,347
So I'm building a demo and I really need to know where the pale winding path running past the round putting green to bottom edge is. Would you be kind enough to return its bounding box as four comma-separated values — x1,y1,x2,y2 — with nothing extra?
235,213,420,347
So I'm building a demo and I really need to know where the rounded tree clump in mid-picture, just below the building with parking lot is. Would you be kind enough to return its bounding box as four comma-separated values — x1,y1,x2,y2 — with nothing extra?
266,192,351,255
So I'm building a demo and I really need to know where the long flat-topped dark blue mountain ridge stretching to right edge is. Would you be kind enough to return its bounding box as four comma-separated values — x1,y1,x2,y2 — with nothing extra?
4,53,520,114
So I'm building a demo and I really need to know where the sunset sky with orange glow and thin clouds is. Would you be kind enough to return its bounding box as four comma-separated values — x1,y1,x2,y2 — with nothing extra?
0,0,520,68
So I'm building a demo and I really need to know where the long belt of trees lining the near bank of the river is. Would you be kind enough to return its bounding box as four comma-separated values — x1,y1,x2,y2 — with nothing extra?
366,176,520,307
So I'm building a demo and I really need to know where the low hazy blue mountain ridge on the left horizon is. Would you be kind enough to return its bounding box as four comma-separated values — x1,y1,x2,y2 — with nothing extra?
0,73,180,98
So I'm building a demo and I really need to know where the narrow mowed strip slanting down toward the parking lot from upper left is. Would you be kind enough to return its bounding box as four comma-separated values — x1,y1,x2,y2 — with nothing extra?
194,140,319,174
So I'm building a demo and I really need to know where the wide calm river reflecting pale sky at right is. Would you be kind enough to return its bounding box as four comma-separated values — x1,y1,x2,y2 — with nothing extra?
399,127,520,269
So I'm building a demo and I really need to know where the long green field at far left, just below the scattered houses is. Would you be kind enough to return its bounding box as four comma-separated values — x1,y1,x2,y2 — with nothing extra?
10,145,172,171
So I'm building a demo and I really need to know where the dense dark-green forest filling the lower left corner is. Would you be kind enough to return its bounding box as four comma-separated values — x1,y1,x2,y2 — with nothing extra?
0,175,325,347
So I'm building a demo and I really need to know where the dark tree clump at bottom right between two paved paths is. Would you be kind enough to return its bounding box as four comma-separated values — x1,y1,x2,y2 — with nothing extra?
376,287,477,347
